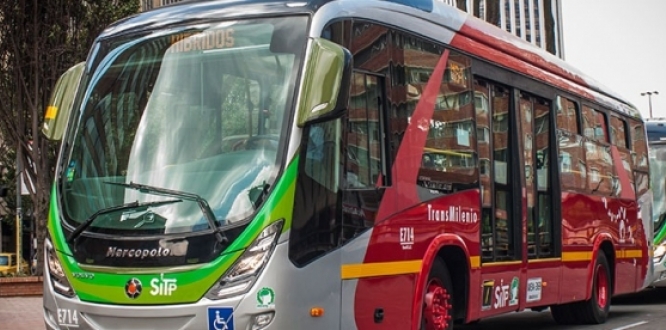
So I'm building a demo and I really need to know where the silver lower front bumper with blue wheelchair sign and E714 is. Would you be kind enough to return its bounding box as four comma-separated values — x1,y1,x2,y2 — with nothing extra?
42,243,340,330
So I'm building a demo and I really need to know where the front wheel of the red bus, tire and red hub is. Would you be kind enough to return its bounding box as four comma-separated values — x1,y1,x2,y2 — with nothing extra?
421,258,453,330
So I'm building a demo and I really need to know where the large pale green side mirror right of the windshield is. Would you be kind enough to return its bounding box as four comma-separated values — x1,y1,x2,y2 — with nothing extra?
297,38,352,127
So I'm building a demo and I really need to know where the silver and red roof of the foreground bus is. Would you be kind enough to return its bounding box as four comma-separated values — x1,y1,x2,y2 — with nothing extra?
99,0,641,118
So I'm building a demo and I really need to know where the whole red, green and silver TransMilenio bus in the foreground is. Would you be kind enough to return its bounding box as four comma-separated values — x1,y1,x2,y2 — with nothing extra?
44,0,653,330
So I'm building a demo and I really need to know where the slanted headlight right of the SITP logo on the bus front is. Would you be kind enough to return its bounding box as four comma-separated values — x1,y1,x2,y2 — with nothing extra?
206,220,284,300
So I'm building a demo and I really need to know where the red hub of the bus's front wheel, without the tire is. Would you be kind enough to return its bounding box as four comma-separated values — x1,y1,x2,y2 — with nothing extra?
423,280,452,330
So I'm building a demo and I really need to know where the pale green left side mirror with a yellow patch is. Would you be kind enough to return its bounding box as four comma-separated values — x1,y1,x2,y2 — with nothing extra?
42,62,86,141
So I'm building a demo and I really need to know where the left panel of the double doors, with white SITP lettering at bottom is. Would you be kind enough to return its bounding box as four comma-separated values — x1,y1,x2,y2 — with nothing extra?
478,79,523,317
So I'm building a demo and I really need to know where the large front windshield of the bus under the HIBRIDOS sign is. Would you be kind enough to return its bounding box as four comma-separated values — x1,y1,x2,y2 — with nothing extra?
61,17,307,236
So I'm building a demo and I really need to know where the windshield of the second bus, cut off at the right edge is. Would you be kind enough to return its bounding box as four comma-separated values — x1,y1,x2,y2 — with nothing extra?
650,144,666,231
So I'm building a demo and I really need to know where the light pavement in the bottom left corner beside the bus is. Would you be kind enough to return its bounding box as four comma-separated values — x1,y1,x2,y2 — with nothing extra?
0,297,45,330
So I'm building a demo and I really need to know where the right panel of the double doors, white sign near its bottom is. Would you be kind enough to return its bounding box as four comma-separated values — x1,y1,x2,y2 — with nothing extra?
516,92,561,309
